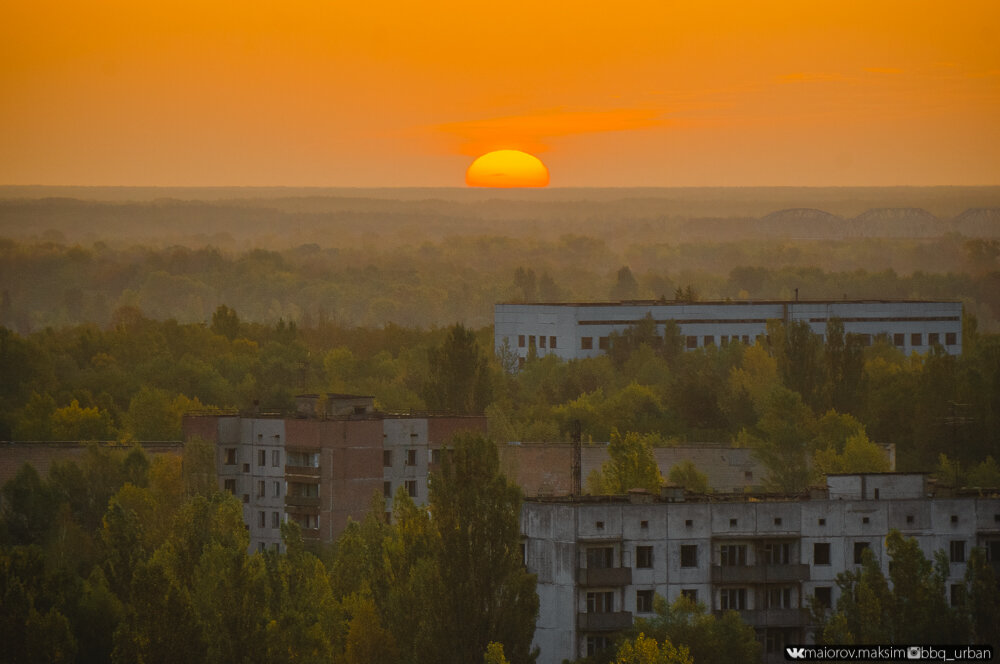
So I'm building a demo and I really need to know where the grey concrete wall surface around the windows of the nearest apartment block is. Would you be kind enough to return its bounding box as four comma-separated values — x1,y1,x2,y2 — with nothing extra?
522,486,1000,664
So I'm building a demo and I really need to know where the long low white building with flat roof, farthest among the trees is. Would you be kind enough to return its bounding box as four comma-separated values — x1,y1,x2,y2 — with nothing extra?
493,300,962,363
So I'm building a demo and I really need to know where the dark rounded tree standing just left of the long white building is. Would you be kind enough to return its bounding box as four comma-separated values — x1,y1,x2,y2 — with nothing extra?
423,325,492,414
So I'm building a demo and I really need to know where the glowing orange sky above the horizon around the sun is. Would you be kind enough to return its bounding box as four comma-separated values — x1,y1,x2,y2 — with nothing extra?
0,0,1000,186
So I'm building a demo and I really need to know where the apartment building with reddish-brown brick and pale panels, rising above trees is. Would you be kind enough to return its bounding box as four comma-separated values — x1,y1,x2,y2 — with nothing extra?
184,395,486,550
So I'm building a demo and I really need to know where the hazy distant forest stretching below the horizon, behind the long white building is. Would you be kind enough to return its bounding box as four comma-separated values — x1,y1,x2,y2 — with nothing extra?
0,187,1000,334
